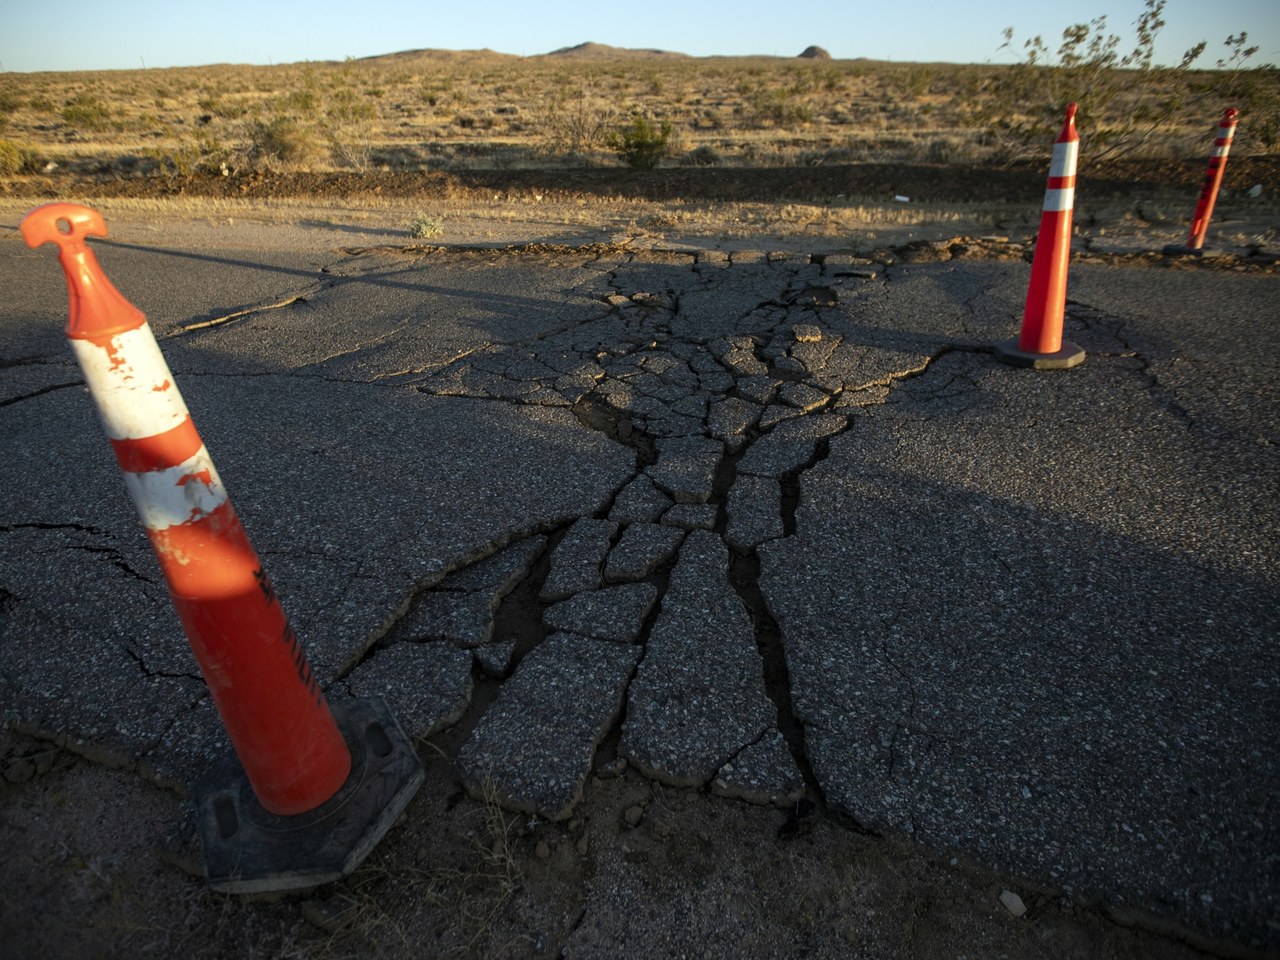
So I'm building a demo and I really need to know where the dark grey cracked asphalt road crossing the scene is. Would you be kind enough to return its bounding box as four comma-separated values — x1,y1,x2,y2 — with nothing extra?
0,224,1280,948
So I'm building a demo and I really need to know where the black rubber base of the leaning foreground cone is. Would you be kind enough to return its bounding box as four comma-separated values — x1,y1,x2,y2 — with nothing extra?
195,698,424,893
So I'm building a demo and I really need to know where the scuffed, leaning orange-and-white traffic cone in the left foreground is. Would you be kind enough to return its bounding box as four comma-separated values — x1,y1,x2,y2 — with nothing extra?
22,204,422,892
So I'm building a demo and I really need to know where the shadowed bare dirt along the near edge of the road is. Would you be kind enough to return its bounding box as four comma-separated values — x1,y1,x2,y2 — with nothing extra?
0,710,1235,960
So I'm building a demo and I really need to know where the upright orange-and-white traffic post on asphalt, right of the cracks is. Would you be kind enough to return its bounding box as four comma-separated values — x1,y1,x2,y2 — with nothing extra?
996,104,1084,370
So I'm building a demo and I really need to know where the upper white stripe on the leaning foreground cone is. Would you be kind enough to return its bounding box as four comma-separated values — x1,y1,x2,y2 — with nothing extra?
68,324,187,440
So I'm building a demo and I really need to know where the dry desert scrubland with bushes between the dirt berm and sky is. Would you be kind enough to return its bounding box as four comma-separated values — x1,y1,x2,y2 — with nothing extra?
0,0,1280,184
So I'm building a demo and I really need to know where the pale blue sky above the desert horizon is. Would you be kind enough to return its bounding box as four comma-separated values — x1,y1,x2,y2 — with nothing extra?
0,0,1280,72
